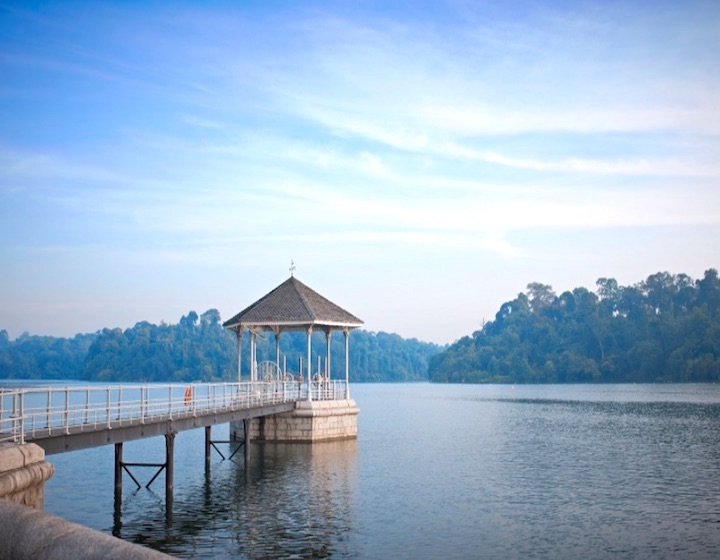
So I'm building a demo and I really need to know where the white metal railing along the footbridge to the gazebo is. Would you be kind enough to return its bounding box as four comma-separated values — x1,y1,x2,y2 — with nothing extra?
0,380,346,443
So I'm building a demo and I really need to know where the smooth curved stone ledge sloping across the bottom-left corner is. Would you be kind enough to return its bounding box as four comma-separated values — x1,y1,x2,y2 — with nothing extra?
0,500,171,560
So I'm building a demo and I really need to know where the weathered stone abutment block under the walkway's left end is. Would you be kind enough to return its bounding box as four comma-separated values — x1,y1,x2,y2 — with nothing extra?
0,443,55,510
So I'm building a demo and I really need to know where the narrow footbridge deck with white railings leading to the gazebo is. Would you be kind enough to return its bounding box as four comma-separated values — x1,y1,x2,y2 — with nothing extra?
0,380,347,454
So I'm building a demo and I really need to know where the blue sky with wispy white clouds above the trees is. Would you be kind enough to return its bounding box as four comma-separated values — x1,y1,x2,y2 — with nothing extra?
0,0,720,344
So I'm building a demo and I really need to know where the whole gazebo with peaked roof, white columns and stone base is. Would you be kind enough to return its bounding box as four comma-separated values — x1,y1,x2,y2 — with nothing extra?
223,275,363,442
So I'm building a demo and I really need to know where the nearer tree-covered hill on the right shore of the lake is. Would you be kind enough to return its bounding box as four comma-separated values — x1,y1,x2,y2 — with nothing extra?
429,269,720,383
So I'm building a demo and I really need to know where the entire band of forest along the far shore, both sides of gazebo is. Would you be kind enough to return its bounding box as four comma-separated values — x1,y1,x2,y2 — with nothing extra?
0,269,720,383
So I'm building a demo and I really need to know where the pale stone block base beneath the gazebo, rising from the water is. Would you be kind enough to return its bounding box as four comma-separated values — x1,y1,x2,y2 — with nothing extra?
230,400,360,443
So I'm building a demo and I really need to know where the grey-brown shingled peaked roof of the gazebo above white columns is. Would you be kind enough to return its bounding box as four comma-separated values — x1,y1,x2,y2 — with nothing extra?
223,276,363,332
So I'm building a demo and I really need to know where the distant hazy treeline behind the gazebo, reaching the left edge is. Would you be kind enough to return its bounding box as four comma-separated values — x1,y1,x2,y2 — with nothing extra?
0,309,441,383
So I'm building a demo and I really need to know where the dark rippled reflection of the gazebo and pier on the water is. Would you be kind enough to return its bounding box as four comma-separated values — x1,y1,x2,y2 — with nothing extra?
112,440,357,560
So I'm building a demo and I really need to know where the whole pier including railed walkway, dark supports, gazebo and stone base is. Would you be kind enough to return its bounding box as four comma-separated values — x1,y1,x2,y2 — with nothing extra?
0,267,363,554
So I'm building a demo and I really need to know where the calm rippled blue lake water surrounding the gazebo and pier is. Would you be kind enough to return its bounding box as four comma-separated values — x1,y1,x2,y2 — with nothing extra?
45,384,720,560
